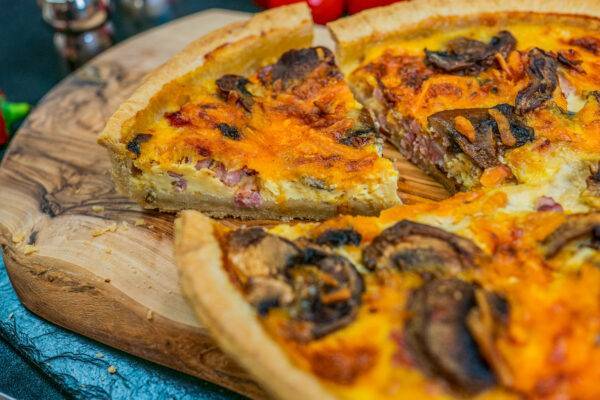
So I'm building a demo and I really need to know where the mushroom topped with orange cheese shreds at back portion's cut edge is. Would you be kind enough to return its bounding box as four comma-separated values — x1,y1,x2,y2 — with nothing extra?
427,104,534,169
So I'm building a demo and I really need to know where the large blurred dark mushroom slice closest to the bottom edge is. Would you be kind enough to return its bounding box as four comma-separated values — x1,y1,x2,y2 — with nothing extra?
404,279,496,394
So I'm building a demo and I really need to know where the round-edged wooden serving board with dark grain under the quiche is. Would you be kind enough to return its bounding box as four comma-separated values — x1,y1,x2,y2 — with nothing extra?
0,10,446,398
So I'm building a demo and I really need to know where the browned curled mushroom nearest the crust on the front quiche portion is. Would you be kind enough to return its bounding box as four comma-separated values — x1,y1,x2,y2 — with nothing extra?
227,228,364,341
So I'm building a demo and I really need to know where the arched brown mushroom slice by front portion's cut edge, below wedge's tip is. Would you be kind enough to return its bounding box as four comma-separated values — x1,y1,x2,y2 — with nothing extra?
363,220,482,276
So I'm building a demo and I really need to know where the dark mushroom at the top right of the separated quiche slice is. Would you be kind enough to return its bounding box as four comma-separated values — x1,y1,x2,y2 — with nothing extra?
259,46,341,87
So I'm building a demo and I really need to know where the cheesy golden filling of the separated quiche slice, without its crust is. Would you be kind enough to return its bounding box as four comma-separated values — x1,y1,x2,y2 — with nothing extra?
117,47,399,211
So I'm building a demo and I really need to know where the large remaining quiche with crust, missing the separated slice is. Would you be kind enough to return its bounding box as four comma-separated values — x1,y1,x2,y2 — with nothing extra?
170,0,600,400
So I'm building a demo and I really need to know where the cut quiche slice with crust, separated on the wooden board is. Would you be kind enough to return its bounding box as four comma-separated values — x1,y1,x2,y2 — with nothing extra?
99,4,399,219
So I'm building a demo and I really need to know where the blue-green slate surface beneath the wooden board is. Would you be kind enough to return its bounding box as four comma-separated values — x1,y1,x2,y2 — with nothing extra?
0,255,243,400
